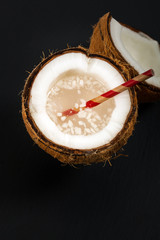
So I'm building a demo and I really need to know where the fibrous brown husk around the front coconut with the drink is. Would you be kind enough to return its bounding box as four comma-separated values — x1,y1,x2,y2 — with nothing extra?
22,47,137,165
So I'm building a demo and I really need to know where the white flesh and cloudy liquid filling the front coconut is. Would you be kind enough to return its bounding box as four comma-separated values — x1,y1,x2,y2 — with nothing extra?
29,52,131,149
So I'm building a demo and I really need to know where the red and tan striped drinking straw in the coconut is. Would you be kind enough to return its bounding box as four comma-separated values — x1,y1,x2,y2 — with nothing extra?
62,69,154,116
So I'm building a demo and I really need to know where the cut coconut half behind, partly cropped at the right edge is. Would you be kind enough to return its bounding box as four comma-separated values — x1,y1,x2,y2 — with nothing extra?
89,13,160,102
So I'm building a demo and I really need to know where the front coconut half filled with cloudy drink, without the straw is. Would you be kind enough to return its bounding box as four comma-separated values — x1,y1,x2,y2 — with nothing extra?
22,47,137,164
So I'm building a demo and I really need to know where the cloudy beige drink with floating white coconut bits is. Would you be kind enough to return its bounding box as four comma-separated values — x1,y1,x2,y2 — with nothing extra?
46,70,115,135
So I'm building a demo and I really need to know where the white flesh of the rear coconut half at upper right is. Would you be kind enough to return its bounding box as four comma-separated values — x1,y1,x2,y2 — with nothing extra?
110,18,160,87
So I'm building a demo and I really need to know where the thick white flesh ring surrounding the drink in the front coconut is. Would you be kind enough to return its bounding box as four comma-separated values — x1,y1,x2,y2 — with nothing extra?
29,53,131,149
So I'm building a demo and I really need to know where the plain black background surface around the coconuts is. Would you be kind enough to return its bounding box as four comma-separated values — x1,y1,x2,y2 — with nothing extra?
0,0,160,240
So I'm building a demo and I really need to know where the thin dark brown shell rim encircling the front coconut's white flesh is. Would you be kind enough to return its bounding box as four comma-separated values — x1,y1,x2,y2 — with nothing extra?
22,47,137,155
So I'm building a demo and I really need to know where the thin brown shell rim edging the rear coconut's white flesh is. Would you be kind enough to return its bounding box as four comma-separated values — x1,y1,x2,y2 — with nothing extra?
104,12,160,93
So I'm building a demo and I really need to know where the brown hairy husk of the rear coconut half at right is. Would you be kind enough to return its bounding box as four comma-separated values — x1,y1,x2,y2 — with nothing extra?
89,12,160,103
